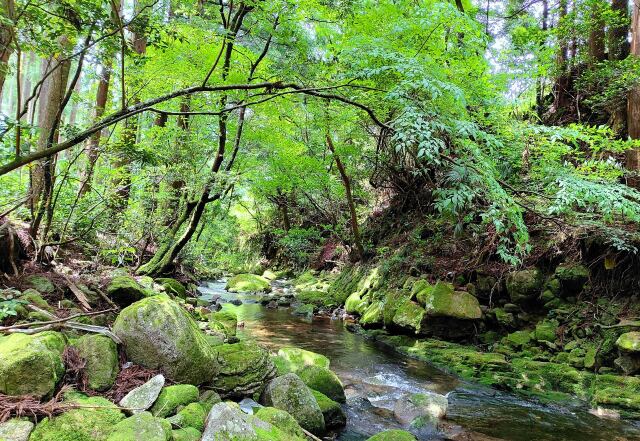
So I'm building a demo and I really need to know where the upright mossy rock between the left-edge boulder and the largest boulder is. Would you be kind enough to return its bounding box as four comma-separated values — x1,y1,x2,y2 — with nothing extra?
73,335,120,391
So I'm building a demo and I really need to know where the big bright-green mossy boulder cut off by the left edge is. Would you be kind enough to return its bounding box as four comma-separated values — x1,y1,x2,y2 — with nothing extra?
0,331,66,397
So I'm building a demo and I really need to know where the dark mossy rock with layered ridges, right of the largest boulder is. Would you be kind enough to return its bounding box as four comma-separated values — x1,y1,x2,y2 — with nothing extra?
212,341,276,398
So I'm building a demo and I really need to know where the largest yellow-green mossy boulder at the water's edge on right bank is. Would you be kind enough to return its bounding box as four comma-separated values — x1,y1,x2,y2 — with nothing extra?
418,282,482,320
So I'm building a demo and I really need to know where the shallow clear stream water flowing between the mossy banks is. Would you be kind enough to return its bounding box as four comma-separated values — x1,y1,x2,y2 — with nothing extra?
199,281,640,441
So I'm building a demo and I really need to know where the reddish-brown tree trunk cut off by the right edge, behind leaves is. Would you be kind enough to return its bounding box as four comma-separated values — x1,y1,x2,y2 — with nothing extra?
627,1,640,188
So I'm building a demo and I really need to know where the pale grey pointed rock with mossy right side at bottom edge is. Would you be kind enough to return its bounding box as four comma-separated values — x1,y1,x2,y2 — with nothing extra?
201,402,302,441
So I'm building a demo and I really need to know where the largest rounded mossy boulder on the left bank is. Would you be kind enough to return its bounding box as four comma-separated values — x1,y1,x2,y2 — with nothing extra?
113,295,218,384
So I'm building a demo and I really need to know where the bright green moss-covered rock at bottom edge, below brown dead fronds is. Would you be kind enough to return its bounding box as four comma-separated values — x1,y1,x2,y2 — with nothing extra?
29,393,125,441
